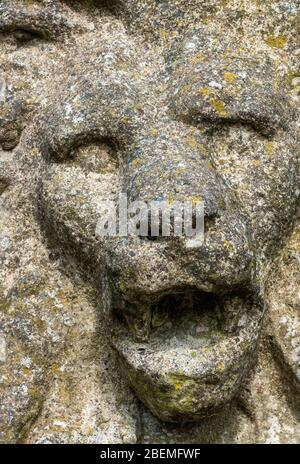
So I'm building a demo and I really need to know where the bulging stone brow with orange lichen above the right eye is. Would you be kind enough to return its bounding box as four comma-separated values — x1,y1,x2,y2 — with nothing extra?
170,50,294,136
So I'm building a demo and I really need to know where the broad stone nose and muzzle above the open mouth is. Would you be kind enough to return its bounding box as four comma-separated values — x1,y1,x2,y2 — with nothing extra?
103,126,253,301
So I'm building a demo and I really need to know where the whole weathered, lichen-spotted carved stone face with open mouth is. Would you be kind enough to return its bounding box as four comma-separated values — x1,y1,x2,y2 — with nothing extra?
1,0,297,422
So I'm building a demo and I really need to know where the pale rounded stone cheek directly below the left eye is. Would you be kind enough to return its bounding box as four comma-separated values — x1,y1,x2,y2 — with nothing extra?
41,165,121,241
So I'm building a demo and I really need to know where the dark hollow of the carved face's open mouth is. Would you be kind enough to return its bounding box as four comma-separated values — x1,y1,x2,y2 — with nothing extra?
114,287,253,349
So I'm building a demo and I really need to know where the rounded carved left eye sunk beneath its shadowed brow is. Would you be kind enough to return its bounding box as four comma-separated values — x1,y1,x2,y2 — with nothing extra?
66,141,119,174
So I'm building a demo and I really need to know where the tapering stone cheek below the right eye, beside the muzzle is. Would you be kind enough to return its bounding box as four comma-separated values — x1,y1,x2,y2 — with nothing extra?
211,126,297,256
